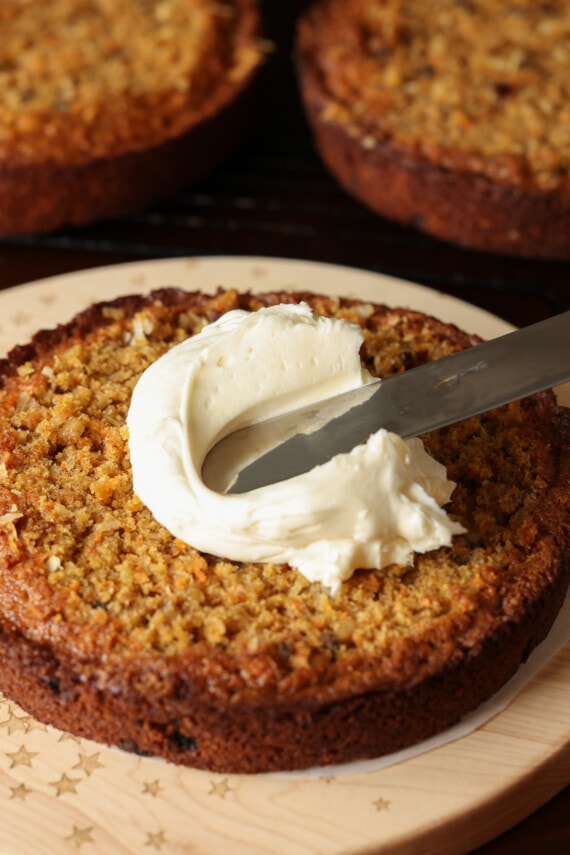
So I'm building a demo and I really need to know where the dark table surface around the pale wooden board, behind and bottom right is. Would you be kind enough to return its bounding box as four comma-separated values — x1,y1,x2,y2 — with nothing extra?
0,0,570,855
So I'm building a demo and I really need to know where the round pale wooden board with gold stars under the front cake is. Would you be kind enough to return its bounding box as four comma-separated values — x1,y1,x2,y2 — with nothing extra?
0,260,570,855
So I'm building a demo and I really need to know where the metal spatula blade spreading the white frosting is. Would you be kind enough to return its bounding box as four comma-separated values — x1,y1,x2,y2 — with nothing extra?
202,312,570,493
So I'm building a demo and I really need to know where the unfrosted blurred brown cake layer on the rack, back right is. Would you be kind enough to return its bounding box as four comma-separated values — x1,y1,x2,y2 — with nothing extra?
296,0,570,258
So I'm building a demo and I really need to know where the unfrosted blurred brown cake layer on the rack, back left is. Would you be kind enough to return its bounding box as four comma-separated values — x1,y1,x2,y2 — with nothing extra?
0,0,264,234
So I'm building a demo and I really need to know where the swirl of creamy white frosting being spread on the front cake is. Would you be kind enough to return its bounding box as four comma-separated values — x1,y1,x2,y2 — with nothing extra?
127,303,464,593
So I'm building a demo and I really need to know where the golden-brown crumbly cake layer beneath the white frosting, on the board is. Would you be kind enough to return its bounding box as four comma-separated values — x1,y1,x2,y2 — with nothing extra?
0,289,570,773
